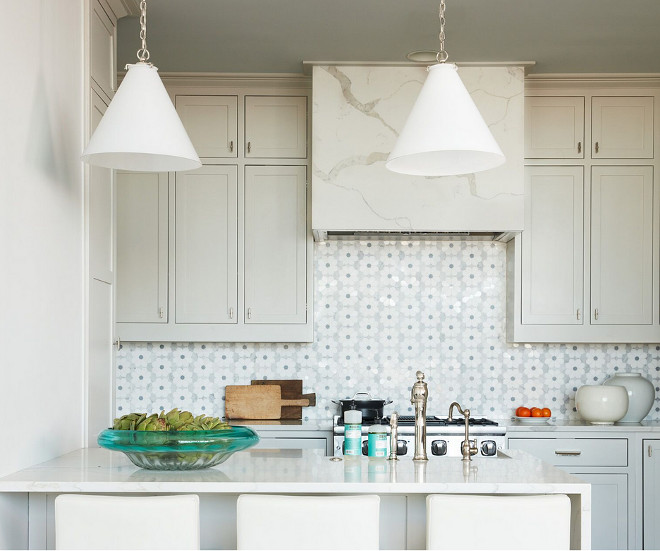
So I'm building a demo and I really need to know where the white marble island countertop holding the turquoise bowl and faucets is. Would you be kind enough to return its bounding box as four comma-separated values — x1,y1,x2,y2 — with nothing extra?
0,448,589,495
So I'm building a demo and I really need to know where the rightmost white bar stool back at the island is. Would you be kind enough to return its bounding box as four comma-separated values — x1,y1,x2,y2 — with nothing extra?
426,494,571,549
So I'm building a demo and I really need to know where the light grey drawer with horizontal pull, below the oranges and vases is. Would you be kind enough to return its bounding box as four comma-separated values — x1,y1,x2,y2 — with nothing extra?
509,438,628,467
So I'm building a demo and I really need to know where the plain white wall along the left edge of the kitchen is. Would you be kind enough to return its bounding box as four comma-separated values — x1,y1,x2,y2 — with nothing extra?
0,0,84,548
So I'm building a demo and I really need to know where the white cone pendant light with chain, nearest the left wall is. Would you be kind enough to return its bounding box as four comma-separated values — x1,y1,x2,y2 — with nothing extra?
82,0,202,172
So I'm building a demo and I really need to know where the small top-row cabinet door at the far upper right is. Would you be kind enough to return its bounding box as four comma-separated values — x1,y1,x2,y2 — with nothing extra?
591,97,653,159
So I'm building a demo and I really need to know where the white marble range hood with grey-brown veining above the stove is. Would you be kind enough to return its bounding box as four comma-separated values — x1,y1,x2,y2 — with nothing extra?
312,65,524,241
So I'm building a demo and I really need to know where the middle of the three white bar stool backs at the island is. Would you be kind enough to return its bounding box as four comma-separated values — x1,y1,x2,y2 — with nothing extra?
236,494,380,549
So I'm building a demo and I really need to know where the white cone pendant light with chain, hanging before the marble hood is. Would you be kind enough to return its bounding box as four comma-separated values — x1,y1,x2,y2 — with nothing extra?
385,0,506,176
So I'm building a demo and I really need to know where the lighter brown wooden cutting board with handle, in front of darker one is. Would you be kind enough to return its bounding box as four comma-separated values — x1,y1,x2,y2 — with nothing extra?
225,385,309,419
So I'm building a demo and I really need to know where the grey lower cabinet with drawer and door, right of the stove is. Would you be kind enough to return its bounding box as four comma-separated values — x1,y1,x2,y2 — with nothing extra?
509,438,632,549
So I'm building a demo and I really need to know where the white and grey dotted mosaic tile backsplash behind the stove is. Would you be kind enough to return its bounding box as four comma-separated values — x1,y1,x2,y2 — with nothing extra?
116,240,660,420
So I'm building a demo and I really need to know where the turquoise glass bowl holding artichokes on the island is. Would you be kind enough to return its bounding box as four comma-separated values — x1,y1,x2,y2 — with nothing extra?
98,427,259,471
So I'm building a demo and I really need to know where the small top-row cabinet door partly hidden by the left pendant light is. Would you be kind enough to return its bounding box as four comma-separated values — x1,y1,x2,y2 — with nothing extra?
176,96,238,158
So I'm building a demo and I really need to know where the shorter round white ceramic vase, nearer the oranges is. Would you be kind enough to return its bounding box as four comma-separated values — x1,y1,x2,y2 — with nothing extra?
575,385,628,425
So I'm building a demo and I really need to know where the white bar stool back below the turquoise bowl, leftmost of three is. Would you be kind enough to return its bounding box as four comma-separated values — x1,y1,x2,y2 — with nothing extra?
55,494,199,549
